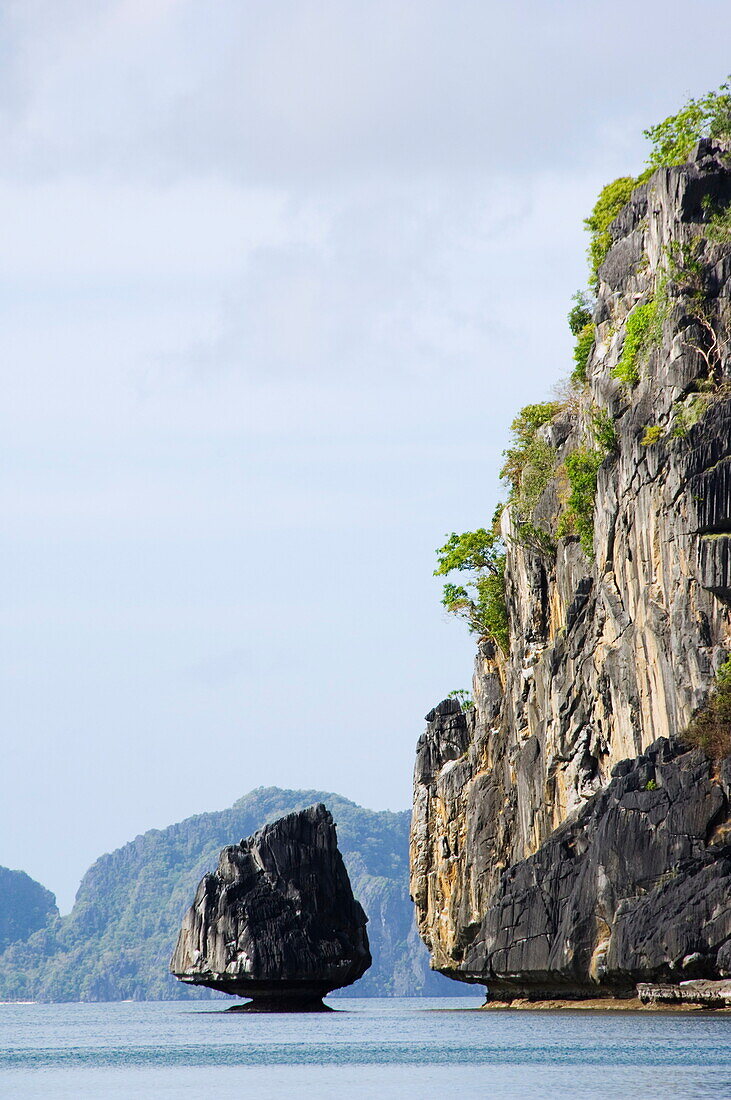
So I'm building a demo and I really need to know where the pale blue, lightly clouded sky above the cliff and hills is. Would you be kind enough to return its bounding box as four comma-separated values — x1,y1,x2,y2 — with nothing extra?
0,0,731,911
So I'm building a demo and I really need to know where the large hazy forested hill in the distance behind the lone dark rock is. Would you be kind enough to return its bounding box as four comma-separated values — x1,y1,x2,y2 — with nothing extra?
0,788,467,1001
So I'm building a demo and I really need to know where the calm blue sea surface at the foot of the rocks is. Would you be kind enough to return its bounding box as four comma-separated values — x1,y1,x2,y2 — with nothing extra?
0,998,731,1100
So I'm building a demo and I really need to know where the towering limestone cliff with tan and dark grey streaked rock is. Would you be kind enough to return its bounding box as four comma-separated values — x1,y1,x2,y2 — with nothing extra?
411,141,731,996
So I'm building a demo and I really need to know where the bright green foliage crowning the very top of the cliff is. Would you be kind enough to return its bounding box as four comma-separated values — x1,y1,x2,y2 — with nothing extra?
643,84,731,176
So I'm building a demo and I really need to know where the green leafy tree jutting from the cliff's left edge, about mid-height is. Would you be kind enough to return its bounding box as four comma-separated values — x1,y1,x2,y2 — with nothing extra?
434,527,509,652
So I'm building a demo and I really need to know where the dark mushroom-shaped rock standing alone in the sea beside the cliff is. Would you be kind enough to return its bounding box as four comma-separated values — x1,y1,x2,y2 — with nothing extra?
170,803,370,1012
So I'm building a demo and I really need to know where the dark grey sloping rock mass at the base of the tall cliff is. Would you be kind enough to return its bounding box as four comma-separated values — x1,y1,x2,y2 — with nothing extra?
464,739,731,1000
